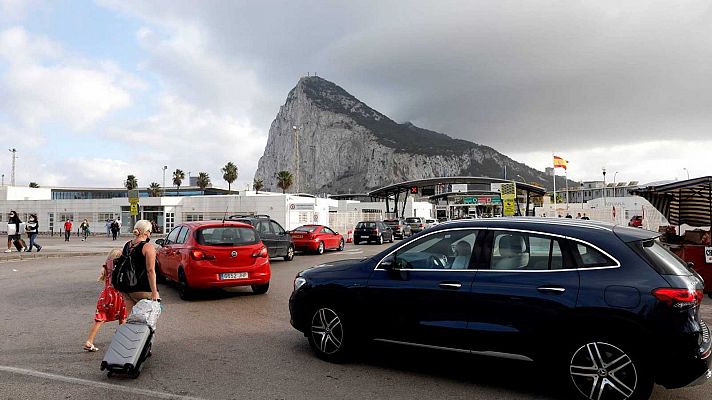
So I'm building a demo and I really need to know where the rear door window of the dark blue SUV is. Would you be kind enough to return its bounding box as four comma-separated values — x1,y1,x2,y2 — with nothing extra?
490,231,571,270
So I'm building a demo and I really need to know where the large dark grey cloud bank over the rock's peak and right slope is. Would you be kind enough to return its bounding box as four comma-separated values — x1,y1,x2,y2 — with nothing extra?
103,1,712,151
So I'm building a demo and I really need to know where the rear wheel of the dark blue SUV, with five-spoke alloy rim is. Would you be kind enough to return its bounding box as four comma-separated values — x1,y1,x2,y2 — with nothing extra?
566,337,653,400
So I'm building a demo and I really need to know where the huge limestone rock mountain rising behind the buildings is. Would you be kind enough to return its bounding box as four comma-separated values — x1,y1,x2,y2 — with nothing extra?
255,77,563,194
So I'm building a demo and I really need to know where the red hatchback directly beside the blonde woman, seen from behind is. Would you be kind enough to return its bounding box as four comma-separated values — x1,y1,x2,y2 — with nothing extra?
156,221,271,300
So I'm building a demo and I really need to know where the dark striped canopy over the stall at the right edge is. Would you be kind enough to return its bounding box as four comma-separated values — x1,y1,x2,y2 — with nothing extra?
631,176,712,226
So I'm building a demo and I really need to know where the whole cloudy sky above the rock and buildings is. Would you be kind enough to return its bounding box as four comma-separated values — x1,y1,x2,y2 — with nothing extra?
0,0,712,188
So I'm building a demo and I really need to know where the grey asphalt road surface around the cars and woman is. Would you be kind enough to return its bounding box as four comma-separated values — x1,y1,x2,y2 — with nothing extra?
0,245,712,400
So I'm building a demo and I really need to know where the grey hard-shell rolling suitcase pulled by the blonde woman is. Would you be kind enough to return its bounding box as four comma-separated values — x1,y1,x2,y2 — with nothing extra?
101,323,153,378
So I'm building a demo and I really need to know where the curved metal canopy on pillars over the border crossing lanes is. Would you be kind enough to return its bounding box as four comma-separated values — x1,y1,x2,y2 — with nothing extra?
368,176,546,217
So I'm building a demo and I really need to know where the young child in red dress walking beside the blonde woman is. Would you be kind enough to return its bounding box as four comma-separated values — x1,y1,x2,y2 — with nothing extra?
83,249,126,352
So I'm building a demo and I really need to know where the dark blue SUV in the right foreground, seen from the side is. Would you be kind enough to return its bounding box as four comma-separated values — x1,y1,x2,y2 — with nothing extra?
289,218,712,399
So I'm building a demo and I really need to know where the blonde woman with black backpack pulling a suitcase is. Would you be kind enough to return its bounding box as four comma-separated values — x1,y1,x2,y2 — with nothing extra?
122,219,161,309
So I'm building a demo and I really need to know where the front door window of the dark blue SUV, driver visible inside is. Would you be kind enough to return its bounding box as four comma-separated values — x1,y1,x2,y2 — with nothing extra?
384,229,478,269
